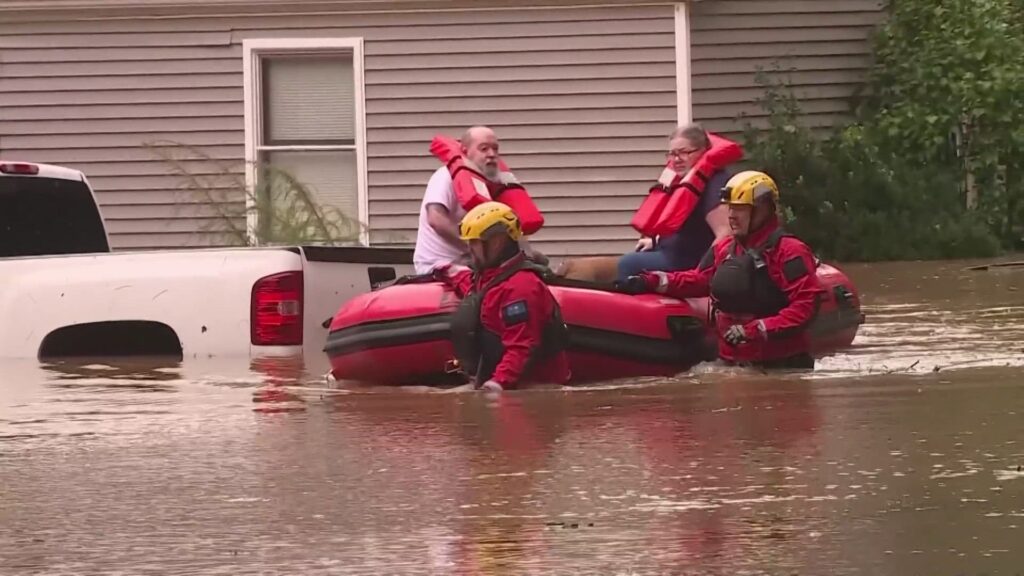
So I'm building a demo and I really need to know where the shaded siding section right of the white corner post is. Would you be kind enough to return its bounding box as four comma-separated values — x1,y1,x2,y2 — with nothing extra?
690,0,884,132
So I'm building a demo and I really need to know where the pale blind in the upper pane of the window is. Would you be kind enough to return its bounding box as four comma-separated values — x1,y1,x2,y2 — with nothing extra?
263,53,355,145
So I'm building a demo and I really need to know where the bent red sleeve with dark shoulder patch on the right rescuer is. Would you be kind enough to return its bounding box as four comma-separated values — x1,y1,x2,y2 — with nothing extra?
759,238,824,339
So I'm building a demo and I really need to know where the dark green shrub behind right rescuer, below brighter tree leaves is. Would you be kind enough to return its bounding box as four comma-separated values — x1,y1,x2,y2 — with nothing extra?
744,77,999,261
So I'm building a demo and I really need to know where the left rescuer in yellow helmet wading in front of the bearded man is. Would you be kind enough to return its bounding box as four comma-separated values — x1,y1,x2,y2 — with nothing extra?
433,202,570,392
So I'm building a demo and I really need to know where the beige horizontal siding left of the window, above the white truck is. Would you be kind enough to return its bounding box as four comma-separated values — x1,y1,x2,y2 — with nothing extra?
0,22,245,249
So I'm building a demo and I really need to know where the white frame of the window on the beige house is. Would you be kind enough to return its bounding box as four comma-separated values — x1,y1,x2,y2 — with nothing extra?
242,38,370,246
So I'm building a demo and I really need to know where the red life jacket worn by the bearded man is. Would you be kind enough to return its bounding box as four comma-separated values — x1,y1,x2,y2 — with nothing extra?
430,135,544,235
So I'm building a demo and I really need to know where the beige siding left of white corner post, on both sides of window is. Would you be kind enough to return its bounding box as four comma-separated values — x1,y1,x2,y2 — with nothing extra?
0,5,676,256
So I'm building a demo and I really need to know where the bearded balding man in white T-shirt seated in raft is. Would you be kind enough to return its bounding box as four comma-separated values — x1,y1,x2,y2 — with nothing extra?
413,126,547,275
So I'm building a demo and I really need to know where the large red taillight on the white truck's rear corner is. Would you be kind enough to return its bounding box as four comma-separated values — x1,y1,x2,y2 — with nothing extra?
249,271,302,346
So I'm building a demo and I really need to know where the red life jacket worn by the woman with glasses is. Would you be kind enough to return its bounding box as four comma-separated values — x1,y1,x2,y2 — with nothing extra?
630,132,743,238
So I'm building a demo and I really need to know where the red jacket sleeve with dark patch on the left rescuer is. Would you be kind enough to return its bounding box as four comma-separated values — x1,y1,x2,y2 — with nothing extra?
487,273,550,388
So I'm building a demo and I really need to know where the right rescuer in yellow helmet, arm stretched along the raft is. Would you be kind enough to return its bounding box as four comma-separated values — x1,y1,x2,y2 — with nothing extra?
621,170,824,369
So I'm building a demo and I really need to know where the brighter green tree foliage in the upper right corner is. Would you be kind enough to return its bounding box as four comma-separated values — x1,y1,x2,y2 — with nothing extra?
858,0,1024,246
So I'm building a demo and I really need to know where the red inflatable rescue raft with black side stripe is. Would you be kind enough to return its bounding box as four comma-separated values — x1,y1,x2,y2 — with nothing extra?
324,264,863,384
